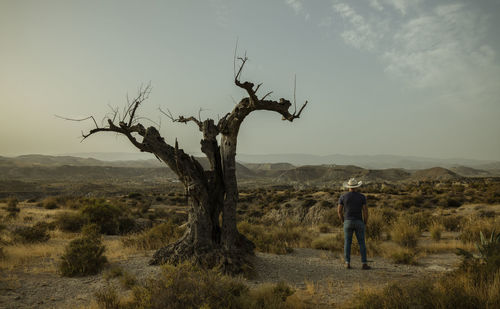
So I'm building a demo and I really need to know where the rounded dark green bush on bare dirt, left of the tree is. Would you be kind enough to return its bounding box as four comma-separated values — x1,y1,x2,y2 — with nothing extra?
59,224,107,277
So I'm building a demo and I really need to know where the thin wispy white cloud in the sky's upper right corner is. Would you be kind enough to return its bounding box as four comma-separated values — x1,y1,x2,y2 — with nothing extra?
333,0,500,103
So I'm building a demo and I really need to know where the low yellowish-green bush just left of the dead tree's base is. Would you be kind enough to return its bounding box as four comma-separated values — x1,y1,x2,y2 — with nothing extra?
122,221,185,250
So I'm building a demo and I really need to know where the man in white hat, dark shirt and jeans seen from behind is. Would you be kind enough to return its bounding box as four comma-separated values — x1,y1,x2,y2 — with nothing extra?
337,178,371,269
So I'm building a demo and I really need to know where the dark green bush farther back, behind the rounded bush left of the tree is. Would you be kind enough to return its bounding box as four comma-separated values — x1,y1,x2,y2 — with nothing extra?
81,202,123,235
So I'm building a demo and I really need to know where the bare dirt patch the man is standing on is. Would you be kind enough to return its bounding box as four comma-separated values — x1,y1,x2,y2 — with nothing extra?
249,249,459,306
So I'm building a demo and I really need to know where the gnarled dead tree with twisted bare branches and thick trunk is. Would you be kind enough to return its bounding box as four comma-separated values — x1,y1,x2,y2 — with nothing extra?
72,57,307,273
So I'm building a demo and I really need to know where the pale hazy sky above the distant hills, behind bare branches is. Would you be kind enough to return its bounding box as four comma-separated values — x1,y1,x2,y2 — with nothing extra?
0,0,500,160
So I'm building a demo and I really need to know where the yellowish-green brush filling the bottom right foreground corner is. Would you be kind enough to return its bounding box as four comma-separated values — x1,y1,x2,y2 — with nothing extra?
345,241,500,309
